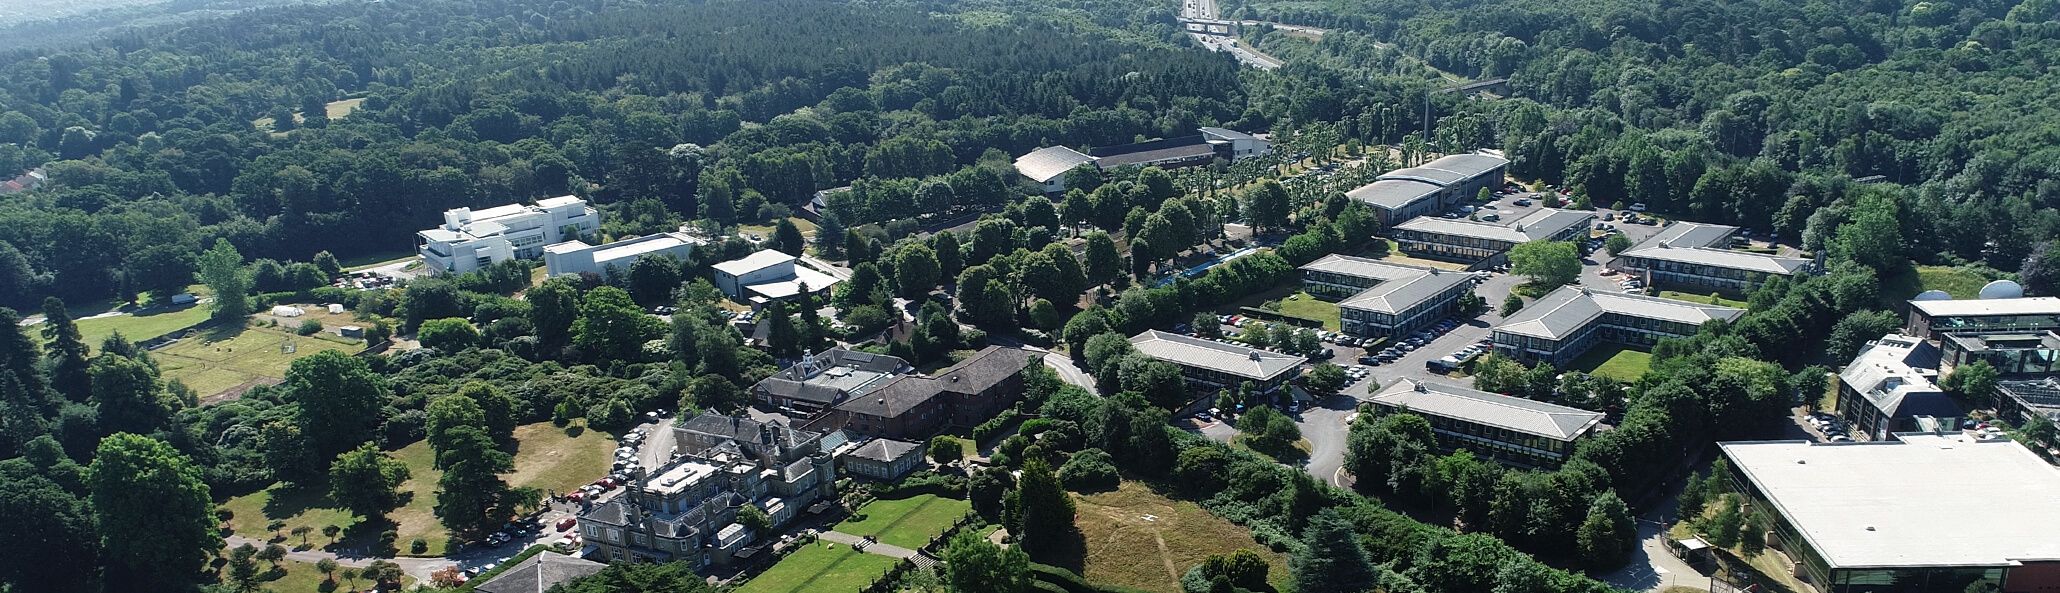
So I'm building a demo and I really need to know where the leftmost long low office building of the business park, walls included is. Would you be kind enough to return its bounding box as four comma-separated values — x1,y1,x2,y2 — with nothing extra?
1131,329,1308,395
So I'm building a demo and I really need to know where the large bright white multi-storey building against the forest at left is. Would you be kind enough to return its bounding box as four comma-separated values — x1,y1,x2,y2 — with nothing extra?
414,196,602,274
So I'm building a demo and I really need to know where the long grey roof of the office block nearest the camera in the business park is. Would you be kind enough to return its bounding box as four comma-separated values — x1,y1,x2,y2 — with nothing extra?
1370,379,1603,441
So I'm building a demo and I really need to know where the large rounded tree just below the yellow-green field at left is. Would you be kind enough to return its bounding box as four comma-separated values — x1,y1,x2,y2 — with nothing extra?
282,350,387,459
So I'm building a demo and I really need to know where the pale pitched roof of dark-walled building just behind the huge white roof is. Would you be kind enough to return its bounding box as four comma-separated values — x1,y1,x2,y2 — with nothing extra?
1838,334,1961,418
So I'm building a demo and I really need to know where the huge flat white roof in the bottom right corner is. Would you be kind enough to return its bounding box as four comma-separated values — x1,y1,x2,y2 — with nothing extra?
1718,434,2060,568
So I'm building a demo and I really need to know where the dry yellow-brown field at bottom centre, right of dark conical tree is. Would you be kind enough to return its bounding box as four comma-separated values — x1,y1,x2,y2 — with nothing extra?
1075,482,1288,593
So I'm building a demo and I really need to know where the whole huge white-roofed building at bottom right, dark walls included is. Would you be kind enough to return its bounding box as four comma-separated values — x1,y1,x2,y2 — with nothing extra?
1718,432,2060,593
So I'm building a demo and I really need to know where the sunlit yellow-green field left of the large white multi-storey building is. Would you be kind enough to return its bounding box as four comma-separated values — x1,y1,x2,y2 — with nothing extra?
158,325,365,399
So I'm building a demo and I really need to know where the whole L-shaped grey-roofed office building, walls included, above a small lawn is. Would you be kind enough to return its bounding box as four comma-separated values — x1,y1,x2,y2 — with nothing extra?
1494,286,1745,367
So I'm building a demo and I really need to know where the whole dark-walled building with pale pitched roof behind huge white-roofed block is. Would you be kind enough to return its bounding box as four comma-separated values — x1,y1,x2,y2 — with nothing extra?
1838,334,1963,441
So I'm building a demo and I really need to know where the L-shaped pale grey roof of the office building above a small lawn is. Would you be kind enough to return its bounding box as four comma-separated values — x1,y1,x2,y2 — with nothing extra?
1496,286,1745,340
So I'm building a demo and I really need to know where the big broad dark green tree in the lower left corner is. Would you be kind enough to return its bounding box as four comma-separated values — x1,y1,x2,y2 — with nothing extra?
87,432,222,591
